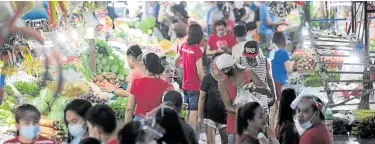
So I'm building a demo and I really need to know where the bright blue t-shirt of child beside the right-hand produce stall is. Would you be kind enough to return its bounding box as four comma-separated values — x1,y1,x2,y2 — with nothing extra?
267,48,290,85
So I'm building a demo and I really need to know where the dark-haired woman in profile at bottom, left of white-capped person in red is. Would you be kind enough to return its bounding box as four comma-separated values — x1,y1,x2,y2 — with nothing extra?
236,102,277,144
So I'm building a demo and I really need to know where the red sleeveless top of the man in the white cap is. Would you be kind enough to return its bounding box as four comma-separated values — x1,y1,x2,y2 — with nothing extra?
225,76,237,134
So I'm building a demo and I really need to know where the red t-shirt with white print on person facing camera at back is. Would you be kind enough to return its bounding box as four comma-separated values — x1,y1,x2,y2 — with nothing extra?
208,33,236,50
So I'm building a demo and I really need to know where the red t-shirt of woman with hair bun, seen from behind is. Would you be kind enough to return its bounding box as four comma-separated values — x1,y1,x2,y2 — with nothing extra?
130,77,173,117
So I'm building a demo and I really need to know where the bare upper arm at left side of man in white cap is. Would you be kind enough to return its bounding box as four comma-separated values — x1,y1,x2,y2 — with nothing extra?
218,80,237,114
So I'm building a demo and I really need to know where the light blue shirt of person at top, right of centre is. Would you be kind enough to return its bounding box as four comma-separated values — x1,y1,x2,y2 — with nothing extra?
258,2,273,36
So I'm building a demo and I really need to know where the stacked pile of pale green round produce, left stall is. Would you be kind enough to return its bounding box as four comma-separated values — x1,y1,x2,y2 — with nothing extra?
96,42,128,81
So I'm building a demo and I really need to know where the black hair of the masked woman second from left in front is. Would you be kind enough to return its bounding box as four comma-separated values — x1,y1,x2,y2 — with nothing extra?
64,99,92,126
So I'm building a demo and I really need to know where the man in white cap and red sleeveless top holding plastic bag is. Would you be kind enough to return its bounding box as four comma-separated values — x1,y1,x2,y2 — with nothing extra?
214,54,270,144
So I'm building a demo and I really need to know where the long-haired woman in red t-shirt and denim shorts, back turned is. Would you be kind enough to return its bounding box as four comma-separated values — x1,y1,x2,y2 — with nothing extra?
174,24,204,130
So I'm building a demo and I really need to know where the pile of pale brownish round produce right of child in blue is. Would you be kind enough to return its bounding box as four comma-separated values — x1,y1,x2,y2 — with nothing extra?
293,52,316,73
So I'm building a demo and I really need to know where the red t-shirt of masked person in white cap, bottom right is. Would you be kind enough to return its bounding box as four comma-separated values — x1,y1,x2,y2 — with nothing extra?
299,123,333,144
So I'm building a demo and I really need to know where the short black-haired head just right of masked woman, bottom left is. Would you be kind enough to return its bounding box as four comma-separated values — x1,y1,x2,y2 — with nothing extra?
86,104,118,144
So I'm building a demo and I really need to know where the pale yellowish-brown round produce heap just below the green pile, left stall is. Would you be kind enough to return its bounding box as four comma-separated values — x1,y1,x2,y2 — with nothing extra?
92,72,121,87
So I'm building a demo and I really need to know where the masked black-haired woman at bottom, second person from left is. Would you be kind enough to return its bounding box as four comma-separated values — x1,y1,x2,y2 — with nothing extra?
64,99,92,144
